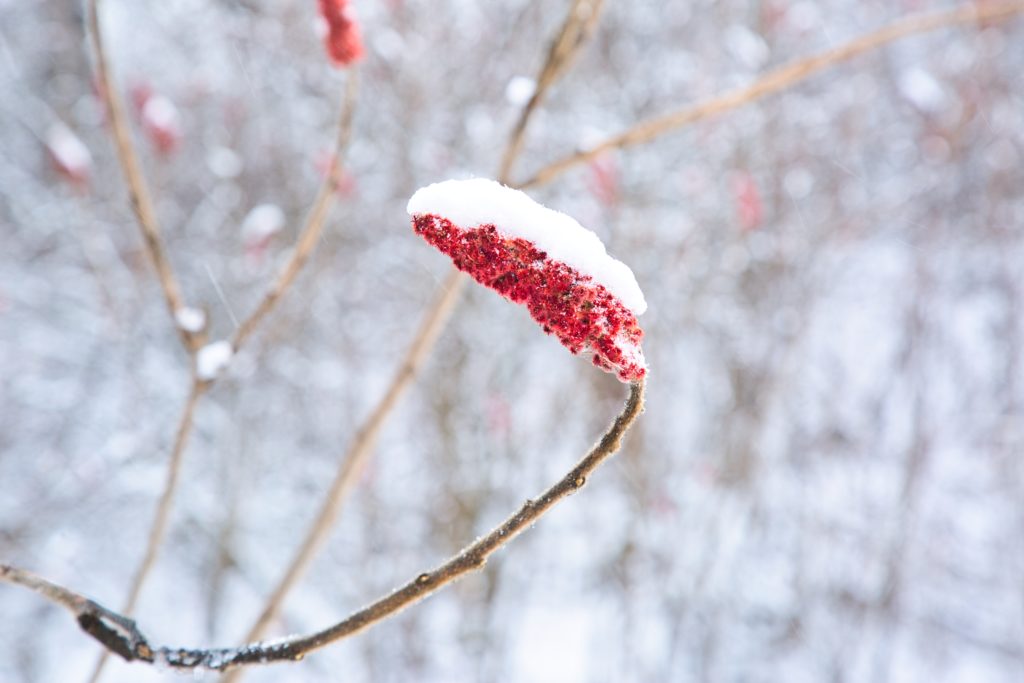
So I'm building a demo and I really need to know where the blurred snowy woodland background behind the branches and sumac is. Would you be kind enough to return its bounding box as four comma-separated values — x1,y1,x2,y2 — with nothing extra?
0,0,1024,683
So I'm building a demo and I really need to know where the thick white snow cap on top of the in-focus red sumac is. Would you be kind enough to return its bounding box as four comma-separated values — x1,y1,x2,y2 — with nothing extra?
407,178,647,315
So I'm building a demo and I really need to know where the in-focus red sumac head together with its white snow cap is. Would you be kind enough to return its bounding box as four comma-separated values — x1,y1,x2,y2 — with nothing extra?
408,178,647,382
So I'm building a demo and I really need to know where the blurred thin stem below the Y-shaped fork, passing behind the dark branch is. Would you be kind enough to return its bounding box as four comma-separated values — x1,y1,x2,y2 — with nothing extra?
83,376,209,683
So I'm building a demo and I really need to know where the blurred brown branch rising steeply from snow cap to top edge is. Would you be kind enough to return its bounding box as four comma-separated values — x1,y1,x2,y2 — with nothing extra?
498,0,604,184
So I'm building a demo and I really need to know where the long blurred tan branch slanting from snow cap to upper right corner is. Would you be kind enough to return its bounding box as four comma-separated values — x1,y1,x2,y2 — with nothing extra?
519,0,1024,187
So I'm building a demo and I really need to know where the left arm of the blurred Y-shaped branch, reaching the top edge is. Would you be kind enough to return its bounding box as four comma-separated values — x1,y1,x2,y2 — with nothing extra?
86,0,200,353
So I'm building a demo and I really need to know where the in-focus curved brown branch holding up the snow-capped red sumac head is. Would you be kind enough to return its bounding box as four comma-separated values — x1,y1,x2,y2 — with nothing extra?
0,382,644,671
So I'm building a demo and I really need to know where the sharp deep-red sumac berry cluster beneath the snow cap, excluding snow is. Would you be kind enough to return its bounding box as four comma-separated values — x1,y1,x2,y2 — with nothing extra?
413,214,647,382
